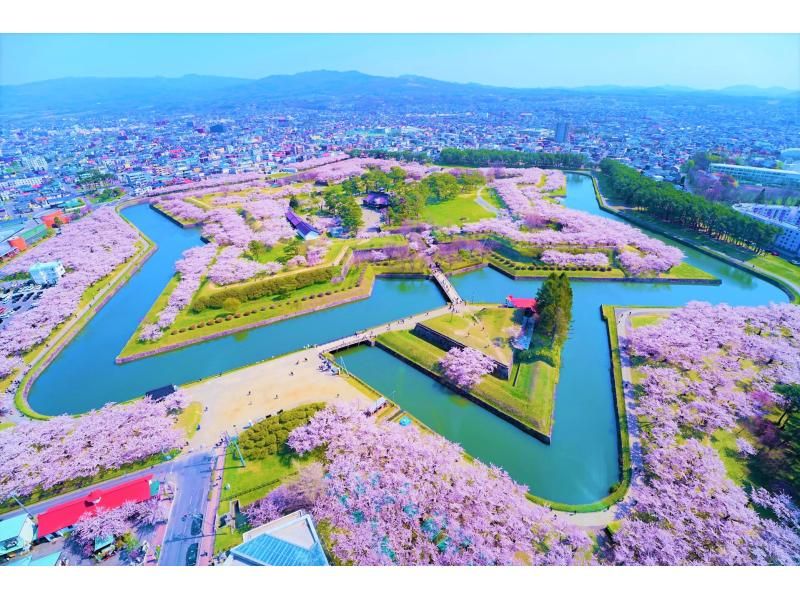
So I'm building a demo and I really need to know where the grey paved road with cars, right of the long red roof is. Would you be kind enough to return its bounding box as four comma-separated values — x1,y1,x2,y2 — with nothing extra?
158,450,213,566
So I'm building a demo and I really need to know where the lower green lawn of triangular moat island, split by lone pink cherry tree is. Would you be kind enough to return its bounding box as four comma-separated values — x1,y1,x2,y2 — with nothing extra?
377,330,558,435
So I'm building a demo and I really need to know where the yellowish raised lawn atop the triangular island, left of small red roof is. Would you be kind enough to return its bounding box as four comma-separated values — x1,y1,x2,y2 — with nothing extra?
425,307,522,363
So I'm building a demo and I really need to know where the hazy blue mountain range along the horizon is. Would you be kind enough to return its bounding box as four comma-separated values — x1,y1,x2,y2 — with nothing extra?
0,71,800,116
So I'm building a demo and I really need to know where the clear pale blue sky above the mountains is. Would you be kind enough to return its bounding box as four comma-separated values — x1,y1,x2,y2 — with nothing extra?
0,34,800,89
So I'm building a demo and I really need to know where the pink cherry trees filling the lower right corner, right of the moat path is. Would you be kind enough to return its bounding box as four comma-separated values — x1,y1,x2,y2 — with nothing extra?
612,302,800,565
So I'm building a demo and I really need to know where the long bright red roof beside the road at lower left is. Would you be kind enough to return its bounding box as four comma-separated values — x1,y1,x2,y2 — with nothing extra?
37,474,153,538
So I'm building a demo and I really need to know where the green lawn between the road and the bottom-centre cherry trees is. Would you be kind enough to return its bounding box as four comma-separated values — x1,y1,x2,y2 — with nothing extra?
214,448,311,554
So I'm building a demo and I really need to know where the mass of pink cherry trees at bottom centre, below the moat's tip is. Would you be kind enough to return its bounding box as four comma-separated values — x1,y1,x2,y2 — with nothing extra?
289,406,591,565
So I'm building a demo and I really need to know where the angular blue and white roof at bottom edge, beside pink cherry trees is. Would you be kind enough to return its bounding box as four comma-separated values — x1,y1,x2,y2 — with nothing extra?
225,510,328,567
